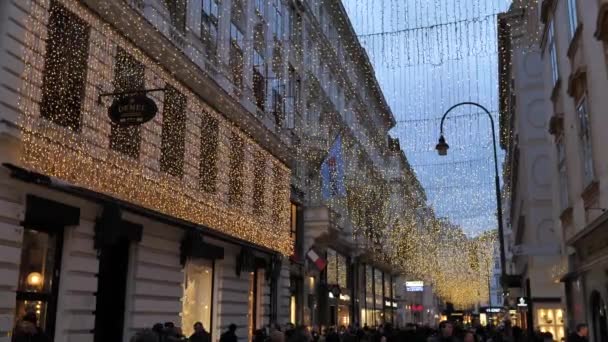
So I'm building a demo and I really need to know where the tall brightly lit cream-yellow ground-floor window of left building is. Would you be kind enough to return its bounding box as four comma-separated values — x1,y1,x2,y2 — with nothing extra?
181,259,213,336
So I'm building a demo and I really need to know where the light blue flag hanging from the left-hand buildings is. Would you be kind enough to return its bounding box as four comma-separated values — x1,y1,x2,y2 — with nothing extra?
321,136,346,200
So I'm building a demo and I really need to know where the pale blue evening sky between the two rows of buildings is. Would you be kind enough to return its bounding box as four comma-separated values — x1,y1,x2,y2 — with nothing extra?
343,0,510,235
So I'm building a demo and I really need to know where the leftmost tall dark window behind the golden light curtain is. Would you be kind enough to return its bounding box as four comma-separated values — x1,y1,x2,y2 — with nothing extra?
40,1,90,131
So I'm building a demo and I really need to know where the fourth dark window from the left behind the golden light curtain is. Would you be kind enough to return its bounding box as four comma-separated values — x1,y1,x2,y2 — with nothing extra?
199,113,219,192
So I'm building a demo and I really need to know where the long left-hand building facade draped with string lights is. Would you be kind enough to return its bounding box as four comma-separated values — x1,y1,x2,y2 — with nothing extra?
0,0,420,342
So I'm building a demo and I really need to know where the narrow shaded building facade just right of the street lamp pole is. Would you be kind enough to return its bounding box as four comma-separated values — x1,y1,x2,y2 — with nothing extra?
499,1,565,340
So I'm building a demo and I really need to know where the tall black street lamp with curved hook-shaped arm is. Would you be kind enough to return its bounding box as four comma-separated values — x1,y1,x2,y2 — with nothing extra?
435,102,506,288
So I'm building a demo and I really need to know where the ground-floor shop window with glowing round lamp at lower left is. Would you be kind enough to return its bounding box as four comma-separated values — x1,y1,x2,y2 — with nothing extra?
15,228,63,336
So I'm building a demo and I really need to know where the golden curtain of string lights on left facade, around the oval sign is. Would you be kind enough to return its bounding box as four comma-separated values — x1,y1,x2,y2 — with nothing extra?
20,0,293,255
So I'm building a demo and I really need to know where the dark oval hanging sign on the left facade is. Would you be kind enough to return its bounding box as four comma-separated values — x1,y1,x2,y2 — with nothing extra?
108,94,158,126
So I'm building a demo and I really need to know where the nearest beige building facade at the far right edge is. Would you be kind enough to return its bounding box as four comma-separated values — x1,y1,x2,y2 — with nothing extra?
502,0,608,341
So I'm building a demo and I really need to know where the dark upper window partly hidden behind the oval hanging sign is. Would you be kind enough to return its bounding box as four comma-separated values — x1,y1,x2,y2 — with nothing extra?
110,48,145,158
